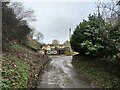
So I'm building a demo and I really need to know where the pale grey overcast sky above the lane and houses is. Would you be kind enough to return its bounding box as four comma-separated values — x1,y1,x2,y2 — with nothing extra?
18,0,109,43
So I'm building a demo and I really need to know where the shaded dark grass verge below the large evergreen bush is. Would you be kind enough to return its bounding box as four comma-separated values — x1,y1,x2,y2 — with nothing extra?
72,56,120,88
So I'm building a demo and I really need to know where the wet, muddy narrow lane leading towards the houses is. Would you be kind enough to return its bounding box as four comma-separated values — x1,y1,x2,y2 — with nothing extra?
38,56,91,88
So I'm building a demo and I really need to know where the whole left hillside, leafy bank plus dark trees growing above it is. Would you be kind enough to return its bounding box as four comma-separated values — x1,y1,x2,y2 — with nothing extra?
0,2,49,90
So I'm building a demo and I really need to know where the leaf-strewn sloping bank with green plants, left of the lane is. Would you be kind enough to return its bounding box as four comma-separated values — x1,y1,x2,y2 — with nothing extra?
2,43,49,90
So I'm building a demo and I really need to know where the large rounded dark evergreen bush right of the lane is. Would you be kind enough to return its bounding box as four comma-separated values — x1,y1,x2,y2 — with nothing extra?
70,14,120,56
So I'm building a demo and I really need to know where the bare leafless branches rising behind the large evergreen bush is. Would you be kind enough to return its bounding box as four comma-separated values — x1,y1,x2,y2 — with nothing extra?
96,0,120,24
